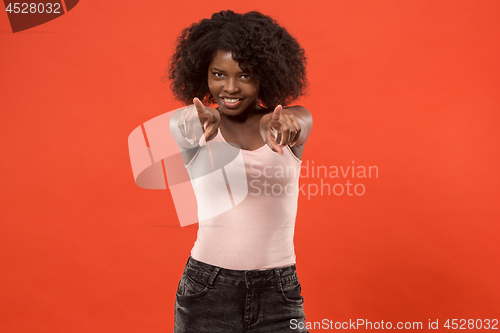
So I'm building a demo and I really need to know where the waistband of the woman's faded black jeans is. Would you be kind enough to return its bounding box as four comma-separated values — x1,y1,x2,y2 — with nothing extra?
184,257,298,288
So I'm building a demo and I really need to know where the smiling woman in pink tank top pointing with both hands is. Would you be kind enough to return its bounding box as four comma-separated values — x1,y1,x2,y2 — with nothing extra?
168,10,312,333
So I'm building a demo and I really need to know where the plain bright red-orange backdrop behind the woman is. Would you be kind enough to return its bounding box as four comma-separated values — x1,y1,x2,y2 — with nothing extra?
0,0,500,333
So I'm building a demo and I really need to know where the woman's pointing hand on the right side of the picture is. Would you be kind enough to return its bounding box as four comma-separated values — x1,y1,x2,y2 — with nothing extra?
260,105,301,156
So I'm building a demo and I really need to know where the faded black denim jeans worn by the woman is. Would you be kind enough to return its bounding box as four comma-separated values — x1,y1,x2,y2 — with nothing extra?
174,257,307,333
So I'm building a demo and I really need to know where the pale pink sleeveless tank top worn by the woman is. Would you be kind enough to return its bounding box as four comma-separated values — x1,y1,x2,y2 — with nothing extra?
186,129,301,270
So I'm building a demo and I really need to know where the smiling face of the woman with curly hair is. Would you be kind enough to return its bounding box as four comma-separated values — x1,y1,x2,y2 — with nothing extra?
208,50,259,116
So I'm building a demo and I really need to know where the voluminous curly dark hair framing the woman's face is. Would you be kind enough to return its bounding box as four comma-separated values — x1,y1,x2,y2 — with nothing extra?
163,10,307,108
